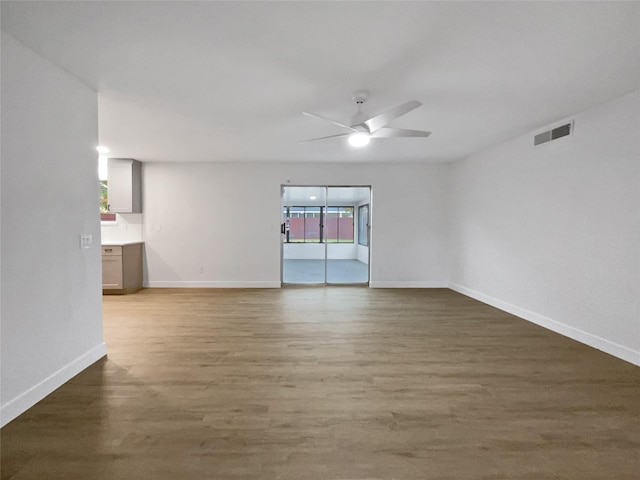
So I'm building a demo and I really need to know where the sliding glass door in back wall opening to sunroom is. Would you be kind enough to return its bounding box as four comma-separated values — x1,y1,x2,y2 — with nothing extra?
280,185,371,285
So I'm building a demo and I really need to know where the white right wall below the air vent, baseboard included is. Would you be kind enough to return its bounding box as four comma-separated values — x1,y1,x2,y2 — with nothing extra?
449,92,640,364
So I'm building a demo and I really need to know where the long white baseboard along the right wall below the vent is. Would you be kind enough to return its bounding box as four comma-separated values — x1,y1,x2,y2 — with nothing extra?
449,283,640,366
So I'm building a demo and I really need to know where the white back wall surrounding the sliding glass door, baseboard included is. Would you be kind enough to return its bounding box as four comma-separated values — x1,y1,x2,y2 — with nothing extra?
143,163,448,287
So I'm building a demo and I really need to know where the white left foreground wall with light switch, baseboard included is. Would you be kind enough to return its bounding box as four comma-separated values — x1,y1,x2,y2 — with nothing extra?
0,32,105,425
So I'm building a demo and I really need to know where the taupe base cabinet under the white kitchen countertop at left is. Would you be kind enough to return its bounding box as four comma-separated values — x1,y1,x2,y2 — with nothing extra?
102,243,142,294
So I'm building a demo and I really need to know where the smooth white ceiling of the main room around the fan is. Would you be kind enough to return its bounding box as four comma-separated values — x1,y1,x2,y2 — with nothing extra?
1,1,640,162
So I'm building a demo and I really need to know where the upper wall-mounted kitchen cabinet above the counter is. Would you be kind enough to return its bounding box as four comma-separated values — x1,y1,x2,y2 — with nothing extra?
107,158,142,213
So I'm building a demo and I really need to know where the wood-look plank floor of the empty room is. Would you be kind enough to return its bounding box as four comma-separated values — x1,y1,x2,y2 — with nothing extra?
1,287,640,480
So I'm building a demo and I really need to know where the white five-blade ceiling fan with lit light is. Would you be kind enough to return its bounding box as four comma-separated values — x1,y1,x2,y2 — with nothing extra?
298,91,431,147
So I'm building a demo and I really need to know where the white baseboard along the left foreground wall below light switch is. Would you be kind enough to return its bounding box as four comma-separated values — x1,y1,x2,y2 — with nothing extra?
0,343,107,427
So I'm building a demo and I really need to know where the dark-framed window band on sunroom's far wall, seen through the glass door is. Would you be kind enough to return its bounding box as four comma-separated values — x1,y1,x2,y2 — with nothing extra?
283,207,354,243
